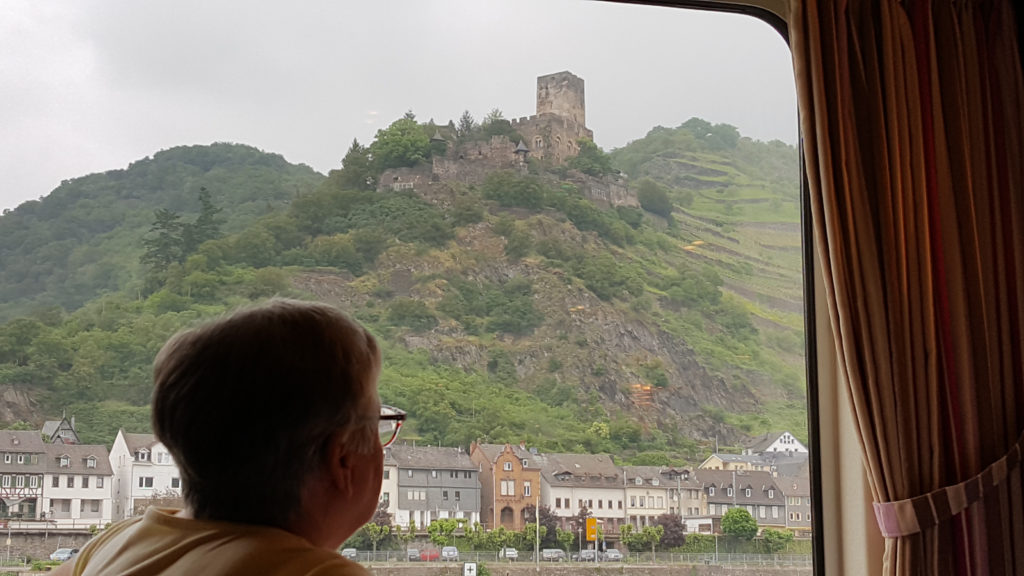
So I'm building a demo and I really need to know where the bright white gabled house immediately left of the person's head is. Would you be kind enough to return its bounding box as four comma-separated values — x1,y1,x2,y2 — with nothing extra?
110,429,182,520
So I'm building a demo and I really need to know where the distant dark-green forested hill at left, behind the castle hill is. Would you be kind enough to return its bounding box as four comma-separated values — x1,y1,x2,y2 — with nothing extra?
0,143,324,320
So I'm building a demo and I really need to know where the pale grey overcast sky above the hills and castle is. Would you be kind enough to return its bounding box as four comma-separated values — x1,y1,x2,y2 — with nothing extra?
0,0,797,209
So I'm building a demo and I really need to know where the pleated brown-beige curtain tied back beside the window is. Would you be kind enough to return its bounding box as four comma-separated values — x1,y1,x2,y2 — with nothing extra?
790,0,1024,575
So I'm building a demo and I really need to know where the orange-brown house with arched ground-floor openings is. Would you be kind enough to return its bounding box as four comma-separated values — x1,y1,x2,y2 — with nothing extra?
469,443,541,530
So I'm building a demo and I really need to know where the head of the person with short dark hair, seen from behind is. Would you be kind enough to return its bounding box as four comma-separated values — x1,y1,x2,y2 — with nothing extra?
153,300,381,528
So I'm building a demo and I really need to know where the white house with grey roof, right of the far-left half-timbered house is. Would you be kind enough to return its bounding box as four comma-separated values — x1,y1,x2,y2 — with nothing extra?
40,442,114,528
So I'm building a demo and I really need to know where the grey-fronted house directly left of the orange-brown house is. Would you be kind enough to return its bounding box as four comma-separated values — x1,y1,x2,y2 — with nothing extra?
387,444,480,531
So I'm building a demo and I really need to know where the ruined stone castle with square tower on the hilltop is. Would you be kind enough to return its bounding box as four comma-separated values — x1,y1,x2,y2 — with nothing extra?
378,71,638,206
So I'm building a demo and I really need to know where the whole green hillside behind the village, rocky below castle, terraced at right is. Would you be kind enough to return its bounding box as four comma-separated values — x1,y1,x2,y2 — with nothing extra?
0,115,806,463
